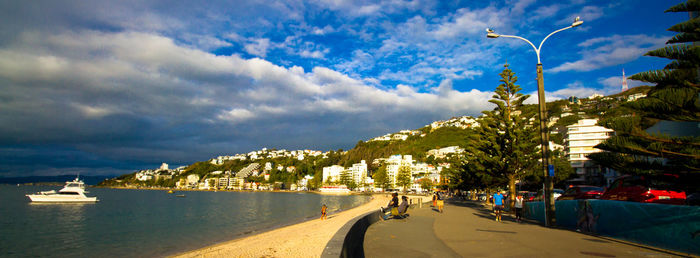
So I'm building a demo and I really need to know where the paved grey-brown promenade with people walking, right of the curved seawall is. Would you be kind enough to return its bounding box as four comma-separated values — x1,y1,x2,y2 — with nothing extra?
364,200,688,257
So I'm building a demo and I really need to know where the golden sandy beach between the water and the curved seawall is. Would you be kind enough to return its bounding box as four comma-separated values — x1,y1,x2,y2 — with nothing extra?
174,194,390,257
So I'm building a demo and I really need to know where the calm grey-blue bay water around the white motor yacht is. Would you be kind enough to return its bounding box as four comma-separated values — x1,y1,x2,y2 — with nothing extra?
0,185,369,257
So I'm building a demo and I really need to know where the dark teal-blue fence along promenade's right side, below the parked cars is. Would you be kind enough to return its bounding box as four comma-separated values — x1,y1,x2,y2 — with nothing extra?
525,200,700,254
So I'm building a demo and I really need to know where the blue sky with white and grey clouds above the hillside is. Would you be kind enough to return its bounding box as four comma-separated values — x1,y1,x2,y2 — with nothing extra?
0,0,688,177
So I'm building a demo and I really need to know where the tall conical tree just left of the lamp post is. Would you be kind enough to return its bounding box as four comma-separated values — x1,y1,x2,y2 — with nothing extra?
470,64,539,208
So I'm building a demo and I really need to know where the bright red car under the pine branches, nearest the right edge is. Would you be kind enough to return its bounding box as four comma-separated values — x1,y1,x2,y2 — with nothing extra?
600,174,686,205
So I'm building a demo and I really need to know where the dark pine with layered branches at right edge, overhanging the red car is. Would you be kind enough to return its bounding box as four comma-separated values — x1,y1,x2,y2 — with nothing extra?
589,0,700,174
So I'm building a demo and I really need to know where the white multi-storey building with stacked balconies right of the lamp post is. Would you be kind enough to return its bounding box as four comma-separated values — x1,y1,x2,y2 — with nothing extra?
565,119,613,185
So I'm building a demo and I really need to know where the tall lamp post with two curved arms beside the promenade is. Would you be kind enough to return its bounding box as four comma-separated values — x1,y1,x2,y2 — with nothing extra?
486,17,583,227
